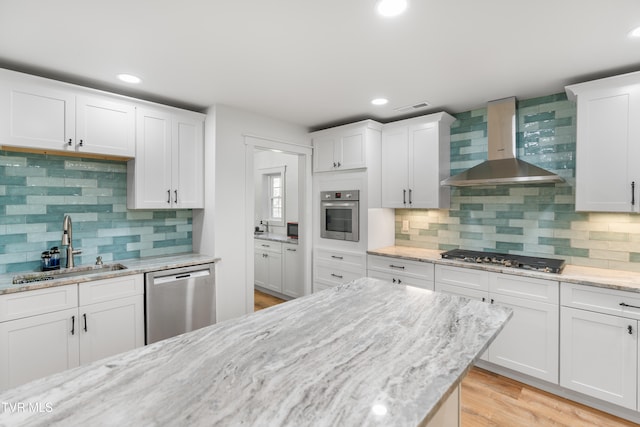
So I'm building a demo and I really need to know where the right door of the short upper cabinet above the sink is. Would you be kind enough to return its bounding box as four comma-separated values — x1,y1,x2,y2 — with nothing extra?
75,96,136,157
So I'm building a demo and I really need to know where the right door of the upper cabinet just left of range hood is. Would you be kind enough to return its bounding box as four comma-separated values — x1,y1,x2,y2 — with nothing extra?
408,123,440,208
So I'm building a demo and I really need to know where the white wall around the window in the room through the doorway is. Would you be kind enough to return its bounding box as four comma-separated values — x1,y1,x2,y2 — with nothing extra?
253,150,298,235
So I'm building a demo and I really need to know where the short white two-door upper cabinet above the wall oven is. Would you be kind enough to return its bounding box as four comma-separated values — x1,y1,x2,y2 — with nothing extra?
311,120,381,172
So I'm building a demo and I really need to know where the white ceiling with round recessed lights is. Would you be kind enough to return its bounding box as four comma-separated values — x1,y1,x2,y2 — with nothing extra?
0,0,640,129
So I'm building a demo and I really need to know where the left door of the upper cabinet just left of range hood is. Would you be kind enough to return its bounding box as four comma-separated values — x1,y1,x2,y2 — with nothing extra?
381,126,409,208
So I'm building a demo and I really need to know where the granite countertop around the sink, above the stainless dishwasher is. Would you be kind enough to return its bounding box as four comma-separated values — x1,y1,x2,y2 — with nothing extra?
0,253,220,295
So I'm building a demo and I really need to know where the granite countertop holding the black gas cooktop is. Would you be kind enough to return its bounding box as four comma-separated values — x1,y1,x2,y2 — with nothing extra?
367,246,640,292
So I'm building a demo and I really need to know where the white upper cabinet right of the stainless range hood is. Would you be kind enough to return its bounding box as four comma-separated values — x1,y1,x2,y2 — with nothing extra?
566,72,640,212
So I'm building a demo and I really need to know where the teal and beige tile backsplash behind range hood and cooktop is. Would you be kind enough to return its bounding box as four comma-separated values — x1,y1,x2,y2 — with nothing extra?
396,93,640,271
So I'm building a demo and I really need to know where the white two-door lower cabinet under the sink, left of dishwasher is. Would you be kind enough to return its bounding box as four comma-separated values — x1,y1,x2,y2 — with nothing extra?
0,275,144,390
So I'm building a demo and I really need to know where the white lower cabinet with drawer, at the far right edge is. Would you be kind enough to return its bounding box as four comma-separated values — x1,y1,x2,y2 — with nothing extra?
560,283,640,410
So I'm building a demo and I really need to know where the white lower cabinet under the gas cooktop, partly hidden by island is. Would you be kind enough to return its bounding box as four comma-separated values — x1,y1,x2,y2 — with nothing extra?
435,265,559,384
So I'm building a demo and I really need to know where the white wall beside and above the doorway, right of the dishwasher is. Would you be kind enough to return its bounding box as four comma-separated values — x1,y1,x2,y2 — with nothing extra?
193,105,311,321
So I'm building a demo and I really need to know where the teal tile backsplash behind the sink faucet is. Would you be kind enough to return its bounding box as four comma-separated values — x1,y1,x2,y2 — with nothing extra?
0,150,192,273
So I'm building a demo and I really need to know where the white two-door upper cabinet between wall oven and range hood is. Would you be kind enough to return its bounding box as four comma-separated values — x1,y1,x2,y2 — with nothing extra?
381,113,455,208
